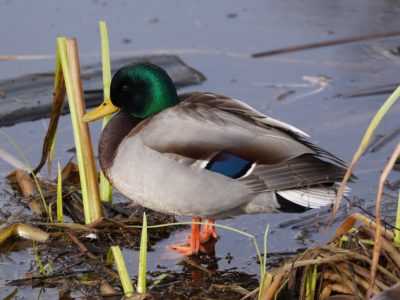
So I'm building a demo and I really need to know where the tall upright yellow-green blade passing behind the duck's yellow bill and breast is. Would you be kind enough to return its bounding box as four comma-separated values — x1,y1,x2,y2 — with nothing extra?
99,21,112,202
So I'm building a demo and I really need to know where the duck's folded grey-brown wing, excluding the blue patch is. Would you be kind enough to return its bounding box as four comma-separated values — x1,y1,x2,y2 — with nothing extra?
132,92,345,193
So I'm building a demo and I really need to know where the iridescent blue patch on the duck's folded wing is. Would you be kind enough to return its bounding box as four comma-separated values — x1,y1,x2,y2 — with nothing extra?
206,153,252,178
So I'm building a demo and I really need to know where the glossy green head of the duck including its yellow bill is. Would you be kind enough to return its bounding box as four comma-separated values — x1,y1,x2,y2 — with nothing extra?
83,63,178,122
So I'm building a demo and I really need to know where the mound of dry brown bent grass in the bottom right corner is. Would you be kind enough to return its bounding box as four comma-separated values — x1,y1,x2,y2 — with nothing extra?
262,213,400,300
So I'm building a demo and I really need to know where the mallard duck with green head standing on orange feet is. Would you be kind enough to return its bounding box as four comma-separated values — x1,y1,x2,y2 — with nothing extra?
84,63,346,255
